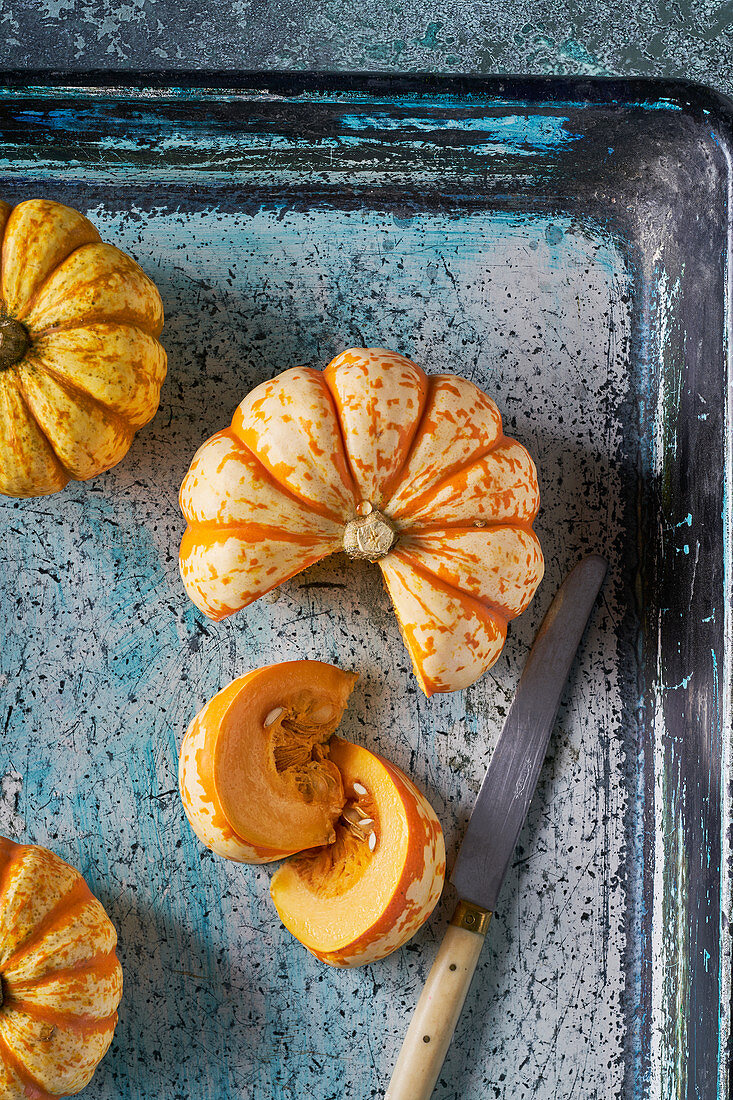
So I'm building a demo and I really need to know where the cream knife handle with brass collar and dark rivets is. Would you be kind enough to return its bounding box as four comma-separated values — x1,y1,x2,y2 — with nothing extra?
384,901,491,1100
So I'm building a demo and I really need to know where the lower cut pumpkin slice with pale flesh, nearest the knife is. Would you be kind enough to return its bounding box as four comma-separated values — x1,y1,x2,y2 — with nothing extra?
270,737,446,967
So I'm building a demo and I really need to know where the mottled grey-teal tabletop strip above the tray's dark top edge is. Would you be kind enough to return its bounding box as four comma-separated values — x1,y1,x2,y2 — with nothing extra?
0,0,733,92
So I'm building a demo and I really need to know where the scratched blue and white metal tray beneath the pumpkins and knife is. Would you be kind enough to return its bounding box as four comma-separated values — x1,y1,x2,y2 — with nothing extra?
0,76,730,1100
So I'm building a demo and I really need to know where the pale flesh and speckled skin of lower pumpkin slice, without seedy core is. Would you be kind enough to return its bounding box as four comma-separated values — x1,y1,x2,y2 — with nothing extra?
270,737,446,967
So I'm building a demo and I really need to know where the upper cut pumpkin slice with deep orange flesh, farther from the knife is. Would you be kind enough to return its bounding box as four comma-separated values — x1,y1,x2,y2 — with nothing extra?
179,661,357,864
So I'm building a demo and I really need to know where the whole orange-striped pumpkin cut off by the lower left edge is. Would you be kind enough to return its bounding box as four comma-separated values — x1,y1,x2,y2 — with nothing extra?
0,837,122,1100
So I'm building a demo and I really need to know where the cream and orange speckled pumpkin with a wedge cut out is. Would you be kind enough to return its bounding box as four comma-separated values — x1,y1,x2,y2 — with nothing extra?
180,348,544,695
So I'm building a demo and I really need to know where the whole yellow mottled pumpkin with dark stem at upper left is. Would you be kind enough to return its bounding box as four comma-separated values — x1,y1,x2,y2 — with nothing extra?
0,199,166,497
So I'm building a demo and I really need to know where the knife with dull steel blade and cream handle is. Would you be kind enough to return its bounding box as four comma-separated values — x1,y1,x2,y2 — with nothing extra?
385,554,608,1100
